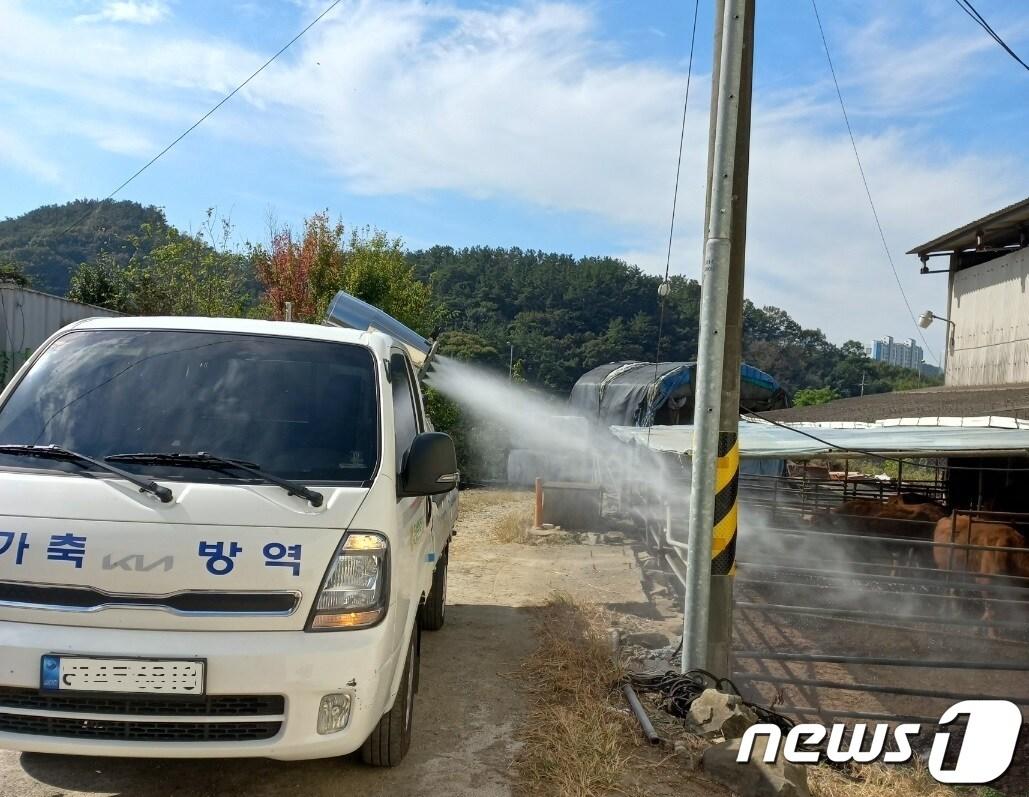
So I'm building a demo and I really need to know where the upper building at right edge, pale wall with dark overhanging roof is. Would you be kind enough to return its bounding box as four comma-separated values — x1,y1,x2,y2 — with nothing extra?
909,197,1029,387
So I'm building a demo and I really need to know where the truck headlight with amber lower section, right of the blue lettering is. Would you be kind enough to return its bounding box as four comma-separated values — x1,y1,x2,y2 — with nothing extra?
308,532,389,630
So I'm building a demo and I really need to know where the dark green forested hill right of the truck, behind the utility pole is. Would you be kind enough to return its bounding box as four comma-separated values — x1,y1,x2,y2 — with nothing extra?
409,247,934,397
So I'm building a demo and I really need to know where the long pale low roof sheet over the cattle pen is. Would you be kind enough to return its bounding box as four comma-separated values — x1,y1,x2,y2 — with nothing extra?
610,418,1029,460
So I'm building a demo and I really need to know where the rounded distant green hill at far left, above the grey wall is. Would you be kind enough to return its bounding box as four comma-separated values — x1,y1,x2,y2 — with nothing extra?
0,200,168,296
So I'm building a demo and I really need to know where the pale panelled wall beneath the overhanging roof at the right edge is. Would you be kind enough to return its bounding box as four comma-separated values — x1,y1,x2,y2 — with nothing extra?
946,248,1029,388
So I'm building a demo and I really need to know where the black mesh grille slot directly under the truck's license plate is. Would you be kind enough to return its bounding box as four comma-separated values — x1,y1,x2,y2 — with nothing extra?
0,686,286,717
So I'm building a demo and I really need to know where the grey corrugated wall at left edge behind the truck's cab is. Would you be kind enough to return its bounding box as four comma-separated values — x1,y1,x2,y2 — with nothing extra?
0,285,118,385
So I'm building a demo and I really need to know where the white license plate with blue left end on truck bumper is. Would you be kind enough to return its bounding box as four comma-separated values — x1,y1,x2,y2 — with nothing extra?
40,655,204,695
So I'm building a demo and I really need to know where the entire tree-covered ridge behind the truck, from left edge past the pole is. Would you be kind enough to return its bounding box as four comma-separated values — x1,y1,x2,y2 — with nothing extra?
0,201,934,401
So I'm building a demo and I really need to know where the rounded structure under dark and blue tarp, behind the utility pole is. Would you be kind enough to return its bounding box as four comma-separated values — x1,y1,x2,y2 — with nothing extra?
568,361,789,427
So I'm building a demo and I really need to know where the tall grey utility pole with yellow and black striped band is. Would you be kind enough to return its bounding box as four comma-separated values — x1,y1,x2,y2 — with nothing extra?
682,0,754,676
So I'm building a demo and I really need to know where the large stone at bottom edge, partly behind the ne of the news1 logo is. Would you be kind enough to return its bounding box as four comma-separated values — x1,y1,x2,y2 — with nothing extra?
702,735,811,797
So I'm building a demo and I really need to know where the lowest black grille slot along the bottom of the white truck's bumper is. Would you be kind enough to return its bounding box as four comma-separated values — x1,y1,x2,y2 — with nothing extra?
0,714,282,741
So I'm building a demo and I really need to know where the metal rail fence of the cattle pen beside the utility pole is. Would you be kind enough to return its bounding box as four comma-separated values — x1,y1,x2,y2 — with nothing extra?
646,475,1029,723
